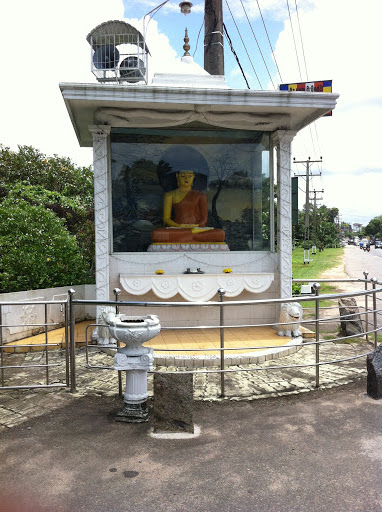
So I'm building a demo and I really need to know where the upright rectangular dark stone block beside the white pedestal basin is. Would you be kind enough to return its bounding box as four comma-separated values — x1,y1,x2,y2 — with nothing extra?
154,373,194,434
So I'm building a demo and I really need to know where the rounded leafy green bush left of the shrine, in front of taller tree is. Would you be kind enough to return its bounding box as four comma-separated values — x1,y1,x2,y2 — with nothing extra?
0,199,92,292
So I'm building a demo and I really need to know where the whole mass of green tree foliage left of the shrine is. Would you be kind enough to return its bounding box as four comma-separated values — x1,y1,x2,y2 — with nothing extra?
0,145,95,291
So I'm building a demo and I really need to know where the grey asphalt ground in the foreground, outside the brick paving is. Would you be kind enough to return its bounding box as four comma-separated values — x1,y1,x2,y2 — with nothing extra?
0,380,382,512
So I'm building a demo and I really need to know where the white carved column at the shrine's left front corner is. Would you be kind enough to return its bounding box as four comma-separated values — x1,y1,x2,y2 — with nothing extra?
89,125,111,306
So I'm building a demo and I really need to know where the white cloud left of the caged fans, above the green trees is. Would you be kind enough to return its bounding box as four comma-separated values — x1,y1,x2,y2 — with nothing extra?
0,0,123,165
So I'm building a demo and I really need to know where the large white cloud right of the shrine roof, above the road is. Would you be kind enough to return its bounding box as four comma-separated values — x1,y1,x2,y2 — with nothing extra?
275,0,382,224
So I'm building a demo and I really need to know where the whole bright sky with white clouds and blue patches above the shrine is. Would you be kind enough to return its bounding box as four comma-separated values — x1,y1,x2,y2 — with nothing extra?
0,0,382,225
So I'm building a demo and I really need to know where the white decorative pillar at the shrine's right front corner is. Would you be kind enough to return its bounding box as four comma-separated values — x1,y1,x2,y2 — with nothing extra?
272,130,297,298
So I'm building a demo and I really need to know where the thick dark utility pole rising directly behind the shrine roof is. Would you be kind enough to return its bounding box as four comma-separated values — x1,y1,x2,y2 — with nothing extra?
204,0,224,75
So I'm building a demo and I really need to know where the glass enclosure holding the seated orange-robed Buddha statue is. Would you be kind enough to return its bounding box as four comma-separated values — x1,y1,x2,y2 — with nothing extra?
111,128,273,252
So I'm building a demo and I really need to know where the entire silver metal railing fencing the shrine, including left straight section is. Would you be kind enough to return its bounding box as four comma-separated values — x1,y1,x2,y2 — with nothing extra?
0,273,382,397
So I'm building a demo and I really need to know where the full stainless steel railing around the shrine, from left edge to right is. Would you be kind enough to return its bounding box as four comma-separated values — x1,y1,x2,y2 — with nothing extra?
0,272,382,397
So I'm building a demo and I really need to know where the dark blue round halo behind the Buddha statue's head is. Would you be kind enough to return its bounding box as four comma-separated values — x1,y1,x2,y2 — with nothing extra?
161,146,209,176
